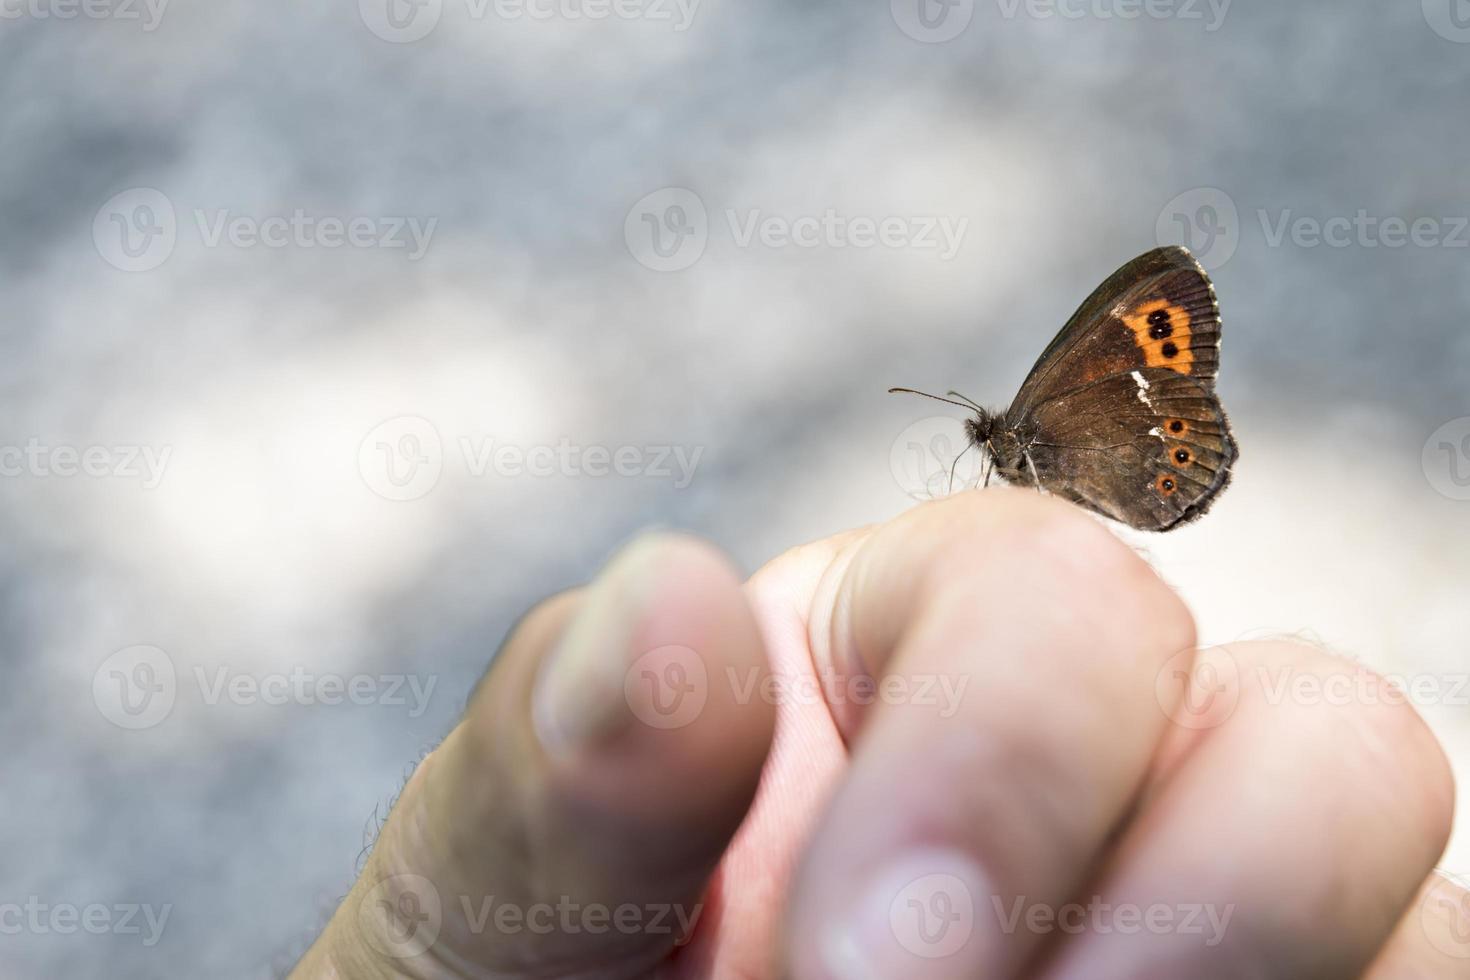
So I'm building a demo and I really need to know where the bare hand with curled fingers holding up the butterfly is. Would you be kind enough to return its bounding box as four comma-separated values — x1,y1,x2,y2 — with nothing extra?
291,488,1470,980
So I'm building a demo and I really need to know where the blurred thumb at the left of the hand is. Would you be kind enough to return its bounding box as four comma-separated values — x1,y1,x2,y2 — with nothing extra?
302,536,772,977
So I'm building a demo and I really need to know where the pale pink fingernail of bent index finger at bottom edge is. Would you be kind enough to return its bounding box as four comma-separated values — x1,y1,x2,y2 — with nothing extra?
819,848,991,980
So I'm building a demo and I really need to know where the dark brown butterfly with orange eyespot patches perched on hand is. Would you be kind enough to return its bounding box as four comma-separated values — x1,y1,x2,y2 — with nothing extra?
889,245,1239,530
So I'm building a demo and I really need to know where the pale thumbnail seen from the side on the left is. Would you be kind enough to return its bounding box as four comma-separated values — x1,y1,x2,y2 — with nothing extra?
531,536,659,754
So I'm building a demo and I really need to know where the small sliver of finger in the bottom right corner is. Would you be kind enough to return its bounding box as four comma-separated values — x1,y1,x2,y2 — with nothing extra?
1364,874,1470,980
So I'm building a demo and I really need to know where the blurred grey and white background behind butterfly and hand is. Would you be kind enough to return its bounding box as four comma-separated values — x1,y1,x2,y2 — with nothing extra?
0,0,1470,980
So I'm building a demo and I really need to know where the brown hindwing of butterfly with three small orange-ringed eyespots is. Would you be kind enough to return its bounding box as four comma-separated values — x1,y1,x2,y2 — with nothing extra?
1026,367,1238,530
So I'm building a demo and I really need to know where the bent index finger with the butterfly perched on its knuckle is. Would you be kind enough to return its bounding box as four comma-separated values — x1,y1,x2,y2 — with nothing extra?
788,491,1194,980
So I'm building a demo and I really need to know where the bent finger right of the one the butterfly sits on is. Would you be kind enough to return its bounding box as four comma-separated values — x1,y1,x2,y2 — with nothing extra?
1044,642,1454,980
